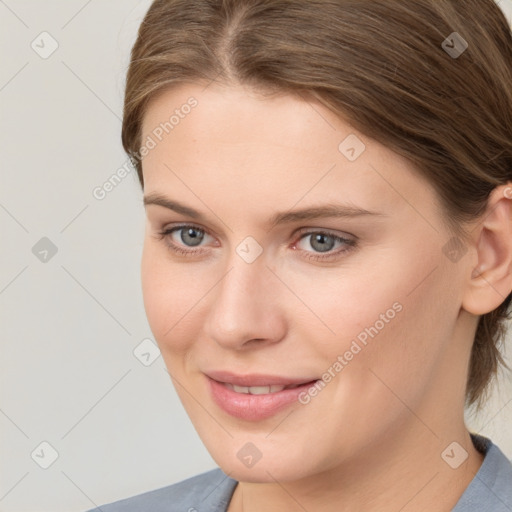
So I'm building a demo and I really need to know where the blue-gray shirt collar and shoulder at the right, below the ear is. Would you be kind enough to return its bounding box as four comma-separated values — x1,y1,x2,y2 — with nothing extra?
452,434,512,512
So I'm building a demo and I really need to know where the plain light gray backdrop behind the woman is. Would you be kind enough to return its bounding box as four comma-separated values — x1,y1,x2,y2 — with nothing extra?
0,0,512,512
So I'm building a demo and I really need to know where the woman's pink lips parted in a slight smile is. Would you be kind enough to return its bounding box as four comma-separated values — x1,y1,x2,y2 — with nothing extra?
206,372,317,421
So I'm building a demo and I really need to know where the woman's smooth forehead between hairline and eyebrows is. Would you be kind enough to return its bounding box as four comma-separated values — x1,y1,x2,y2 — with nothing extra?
142,84,433,224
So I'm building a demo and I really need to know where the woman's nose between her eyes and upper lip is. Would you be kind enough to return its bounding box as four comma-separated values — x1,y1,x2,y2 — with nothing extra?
204,254,286,350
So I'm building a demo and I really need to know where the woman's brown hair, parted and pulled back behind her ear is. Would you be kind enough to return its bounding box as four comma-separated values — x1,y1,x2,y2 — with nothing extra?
122,0,512,409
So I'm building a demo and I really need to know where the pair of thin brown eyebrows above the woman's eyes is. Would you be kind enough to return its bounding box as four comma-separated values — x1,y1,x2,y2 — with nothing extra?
144,193,387,227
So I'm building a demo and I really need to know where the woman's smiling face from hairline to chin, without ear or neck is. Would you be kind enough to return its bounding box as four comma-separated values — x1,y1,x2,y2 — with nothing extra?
142,85,472,481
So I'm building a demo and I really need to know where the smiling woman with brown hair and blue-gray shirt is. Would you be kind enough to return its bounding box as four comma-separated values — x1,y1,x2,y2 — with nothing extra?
89,0,512,512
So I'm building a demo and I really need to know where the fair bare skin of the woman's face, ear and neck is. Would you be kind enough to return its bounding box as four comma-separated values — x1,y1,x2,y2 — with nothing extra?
141,84,512,512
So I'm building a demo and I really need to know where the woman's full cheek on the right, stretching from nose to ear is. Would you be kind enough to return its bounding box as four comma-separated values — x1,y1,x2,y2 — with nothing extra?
294,241,460,387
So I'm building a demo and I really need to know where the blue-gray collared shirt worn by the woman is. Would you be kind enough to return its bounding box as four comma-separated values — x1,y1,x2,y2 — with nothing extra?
88,434,512,512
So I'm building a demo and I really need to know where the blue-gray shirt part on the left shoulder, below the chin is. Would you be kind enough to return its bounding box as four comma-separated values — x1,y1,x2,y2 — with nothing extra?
88,468,237,512
